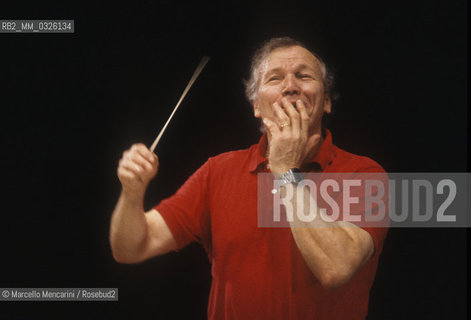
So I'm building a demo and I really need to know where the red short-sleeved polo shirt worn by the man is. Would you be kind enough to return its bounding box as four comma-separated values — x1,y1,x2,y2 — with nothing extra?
155,131,387,320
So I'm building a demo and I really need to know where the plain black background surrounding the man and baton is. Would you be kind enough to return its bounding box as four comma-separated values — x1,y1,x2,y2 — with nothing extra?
0,0,467,319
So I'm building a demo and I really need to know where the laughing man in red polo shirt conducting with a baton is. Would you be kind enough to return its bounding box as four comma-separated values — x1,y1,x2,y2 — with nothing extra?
110,38,387,319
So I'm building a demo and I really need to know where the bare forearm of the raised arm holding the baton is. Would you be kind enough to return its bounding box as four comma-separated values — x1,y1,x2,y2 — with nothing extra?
110,192,148,263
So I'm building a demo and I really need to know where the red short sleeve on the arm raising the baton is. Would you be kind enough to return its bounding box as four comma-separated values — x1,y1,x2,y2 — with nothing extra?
154,162,210,250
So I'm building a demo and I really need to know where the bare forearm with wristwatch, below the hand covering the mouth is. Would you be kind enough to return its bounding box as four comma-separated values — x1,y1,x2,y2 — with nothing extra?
282,185,373,288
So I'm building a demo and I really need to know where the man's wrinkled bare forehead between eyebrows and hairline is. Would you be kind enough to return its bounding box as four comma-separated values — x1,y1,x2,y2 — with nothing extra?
262,46,321,73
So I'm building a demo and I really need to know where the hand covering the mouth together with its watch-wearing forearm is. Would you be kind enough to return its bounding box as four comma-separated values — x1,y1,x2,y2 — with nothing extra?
263,97,374,288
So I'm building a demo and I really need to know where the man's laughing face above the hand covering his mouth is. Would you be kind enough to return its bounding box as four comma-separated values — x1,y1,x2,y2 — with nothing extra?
254,46,331,134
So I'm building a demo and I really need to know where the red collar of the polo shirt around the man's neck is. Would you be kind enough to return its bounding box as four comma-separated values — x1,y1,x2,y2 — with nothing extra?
249,129,335,172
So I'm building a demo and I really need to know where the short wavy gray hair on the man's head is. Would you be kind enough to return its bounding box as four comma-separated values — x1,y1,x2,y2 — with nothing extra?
244,37,337,104
